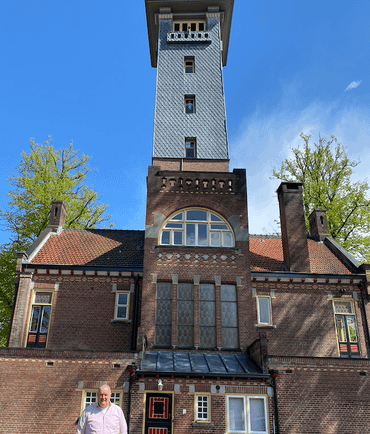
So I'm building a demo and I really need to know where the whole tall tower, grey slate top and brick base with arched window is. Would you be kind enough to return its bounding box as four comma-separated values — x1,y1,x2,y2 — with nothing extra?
141,0,255,351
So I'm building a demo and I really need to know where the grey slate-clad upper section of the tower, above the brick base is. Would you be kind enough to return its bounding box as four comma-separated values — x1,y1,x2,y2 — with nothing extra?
146,0,233,171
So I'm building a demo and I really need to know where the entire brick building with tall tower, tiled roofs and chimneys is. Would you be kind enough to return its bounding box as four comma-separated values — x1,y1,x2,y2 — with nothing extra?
0,0,370,434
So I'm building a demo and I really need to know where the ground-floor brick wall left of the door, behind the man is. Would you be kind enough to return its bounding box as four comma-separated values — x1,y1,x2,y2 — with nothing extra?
0,348,133,434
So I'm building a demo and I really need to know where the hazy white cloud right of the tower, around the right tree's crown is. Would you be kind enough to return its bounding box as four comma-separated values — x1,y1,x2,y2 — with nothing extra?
230,84,370,234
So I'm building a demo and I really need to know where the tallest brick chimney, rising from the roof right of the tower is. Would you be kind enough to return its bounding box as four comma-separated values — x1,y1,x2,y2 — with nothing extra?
277,182,310,273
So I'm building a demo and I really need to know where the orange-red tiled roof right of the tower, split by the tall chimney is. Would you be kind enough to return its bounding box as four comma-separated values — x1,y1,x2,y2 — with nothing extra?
249,235,352,274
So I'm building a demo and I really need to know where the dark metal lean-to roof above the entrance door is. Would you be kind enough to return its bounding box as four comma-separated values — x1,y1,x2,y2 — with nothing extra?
137,351,263,377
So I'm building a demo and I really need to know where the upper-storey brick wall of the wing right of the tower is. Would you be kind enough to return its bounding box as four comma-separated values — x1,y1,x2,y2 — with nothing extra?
252,282,368,358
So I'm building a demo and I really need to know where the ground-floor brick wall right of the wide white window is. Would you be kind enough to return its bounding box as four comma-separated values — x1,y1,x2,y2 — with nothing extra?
270,358,370,434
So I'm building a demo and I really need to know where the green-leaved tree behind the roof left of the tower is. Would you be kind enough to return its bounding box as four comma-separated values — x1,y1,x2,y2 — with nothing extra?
0,137,113,346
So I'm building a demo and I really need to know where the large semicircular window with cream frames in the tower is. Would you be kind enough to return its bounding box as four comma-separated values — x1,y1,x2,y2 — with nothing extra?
159,208,234,247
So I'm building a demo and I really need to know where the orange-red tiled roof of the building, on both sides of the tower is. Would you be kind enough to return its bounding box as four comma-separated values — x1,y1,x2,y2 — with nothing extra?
30,229,353,274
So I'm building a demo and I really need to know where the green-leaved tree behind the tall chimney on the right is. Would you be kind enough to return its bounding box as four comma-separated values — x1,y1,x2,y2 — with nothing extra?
272,133,370,261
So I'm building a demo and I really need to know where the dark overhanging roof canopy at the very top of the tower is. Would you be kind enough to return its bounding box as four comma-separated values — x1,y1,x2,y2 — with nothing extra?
145,0,234,68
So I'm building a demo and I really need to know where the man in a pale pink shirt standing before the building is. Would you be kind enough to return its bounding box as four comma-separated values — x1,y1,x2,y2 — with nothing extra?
76,384,127,434
